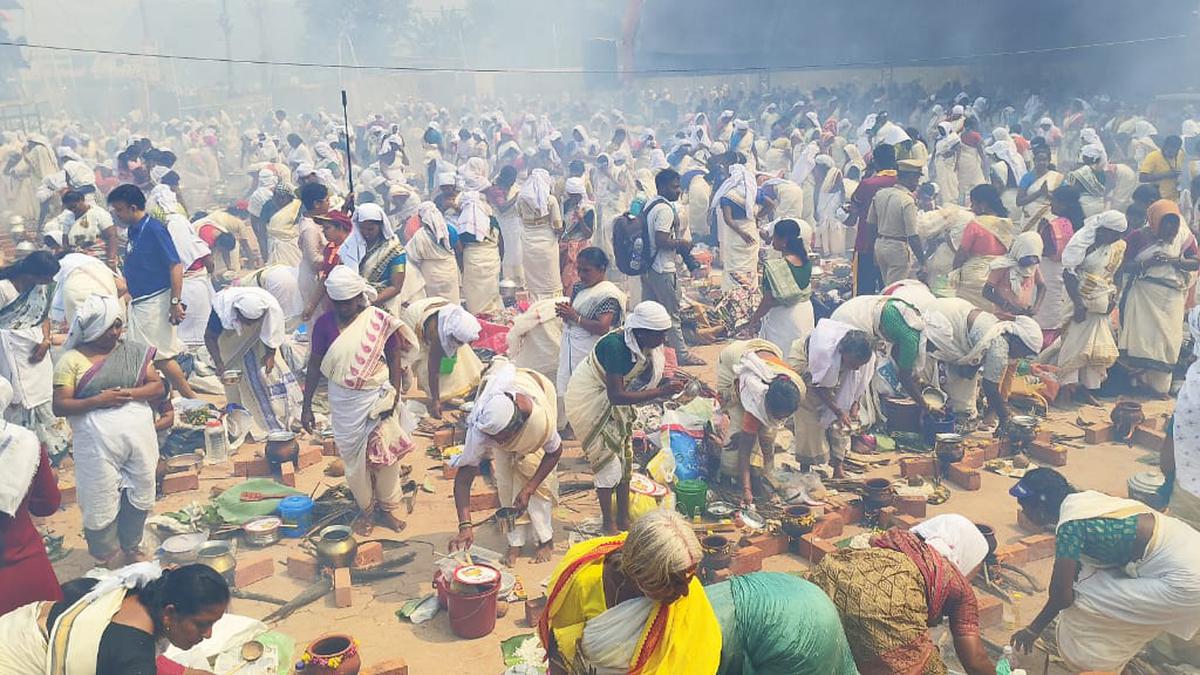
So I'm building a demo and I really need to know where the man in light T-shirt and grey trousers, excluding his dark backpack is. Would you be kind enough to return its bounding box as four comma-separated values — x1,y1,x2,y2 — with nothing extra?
642,168,704,365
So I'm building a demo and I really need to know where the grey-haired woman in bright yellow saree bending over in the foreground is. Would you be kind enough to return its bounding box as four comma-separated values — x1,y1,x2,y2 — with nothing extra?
538,509,721,675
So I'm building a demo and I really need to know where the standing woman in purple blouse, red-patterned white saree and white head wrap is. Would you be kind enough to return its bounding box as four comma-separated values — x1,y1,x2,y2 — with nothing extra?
300,265,416,534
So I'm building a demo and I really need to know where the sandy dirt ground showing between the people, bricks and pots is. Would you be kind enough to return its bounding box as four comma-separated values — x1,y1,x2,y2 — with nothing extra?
42,346,1174,675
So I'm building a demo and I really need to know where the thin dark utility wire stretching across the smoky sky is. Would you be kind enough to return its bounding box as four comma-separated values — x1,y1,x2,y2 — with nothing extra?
0,34,1188,76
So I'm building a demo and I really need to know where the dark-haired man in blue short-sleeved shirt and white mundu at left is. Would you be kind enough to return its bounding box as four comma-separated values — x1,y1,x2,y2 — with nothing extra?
108,184,196,399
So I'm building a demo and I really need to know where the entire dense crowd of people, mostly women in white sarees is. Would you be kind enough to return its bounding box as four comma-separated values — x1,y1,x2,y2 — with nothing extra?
0,77,1200,674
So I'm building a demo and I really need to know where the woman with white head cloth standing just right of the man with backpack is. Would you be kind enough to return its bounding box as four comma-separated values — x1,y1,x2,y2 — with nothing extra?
709,165,762,291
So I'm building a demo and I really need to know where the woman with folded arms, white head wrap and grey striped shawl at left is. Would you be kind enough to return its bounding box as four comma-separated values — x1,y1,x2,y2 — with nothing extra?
54,295,163,567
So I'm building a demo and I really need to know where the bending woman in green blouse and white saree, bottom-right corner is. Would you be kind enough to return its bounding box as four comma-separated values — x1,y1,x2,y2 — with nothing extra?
1009,468,1200,673
